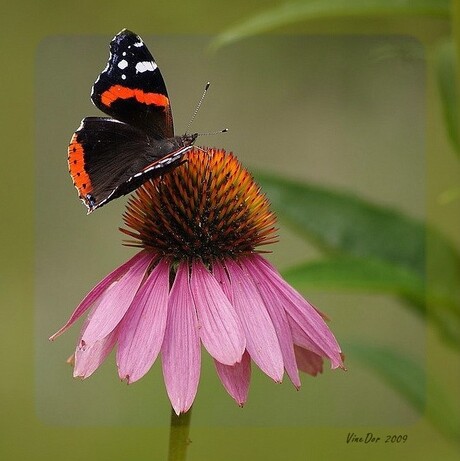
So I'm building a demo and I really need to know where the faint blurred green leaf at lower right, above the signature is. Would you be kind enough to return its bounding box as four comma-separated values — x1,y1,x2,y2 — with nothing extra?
344,342,460,440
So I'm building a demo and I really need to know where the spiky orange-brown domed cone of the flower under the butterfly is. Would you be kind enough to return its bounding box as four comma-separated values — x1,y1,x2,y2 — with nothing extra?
121,148,276,263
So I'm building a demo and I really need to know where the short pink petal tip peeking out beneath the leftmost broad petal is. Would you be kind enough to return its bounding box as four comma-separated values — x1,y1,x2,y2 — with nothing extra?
73,329,117,379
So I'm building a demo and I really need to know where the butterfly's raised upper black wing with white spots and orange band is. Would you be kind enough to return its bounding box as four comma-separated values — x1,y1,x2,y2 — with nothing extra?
91,29,174,139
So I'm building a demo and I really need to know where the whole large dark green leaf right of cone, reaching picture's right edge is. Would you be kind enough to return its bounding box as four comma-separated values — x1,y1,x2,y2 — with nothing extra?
256,174,460,347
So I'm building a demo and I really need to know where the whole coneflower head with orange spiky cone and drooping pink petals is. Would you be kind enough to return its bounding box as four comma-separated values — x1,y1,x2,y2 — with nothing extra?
51,148,343,414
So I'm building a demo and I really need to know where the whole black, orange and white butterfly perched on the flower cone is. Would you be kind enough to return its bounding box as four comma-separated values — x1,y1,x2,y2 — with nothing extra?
68,29,198,213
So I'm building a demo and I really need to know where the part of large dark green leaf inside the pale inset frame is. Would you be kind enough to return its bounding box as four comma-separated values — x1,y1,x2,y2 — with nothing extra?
256,174,425,279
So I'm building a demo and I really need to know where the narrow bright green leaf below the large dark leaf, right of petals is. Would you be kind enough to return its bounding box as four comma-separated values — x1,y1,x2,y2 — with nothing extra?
283,257,425,306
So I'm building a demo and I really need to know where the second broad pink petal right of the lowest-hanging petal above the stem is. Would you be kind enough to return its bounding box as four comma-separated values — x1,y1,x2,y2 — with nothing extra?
225,260,284,382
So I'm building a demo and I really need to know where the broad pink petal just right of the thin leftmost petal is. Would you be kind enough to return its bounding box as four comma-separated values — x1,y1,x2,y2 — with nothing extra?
78,252,154,345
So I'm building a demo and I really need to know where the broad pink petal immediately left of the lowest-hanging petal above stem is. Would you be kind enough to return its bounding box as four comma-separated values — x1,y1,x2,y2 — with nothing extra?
117,260,169,383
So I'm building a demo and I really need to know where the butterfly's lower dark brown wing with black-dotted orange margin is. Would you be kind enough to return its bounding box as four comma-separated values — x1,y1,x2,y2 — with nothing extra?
68,117,191,212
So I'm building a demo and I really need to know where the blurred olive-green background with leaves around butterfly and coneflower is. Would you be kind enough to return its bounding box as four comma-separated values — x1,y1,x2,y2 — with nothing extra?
0,0,460,460
